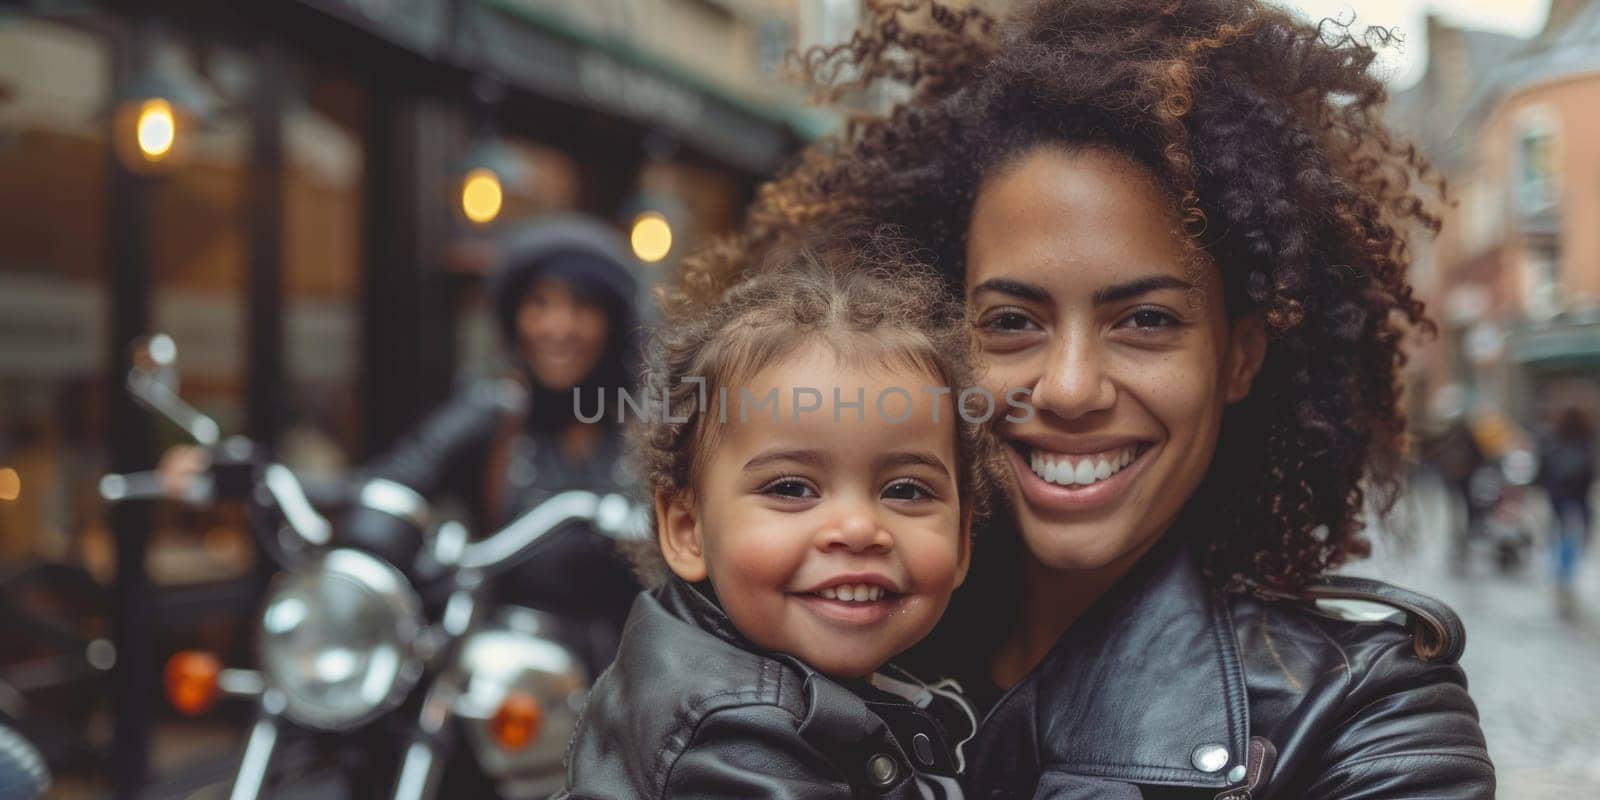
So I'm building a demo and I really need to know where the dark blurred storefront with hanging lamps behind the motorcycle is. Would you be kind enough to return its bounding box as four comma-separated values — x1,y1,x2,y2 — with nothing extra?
0,0,811,795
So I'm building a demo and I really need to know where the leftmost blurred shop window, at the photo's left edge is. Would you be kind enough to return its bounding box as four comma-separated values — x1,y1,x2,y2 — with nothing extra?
0,19,110,563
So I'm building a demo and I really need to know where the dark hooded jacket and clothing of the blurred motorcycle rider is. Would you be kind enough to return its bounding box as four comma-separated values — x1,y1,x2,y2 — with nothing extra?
346,218,638,672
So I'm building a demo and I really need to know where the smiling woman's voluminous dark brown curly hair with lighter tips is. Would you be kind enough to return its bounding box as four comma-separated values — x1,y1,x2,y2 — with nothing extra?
685,0,1445,594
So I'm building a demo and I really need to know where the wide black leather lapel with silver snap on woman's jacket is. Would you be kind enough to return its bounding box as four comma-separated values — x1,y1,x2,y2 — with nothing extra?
1013,536,1250,789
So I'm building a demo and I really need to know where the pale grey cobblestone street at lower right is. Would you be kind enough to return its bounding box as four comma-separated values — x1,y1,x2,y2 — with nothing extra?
1349,485,1600,800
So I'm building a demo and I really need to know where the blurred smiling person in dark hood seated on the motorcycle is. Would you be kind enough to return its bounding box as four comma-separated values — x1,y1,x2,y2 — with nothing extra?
162,216,638,672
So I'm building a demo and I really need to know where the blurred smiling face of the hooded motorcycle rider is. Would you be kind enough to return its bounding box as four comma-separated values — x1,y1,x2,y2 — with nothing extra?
517,278,610,392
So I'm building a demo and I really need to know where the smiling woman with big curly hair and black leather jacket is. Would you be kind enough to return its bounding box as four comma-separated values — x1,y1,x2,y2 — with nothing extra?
686,0,1494,800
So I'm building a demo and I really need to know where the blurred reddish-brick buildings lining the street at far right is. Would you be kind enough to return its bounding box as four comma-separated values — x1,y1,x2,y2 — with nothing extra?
1392,0,1600,429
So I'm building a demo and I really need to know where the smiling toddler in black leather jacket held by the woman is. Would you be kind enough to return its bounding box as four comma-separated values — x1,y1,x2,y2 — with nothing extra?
566,235,992,800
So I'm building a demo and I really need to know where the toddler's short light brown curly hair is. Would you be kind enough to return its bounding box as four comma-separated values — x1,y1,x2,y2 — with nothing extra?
629,229,998,586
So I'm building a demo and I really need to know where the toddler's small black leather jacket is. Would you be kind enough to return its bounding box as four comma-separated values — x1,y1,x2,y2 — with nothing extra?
560,579,955,800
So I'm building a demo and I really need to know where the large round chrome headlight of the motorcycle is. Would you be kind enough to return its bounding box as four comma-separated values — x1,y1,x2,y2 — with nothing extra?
261,550,422,730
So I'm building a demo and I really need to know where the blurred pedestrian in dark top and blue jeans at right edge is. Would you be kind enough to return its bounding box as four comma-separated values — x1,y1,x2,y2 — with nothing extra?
1539,405,1595,618
